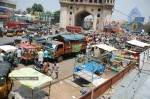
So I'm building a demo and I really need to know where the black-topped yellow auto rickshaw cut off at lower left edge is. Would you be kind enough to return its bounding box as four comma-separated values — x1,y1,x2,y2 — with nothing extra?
0,62,13,99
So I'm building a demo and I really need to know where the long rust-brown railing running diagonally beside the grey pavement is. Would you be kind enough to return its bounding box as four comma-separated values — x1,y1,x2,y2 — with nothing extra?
79,62,135,99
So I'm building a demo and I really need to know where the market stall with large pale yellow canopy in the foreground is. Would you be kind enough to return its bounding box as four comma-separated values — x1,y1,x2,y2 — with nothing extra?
9,68,53,99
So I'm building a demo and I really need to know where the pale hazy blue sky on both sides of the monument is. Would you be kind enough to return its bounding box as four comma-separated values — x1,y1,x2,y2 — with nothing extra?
9,0,150,22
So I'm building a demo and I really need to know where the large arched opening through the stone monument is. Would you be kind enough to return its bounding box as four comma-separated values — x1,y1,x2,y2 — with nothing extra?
75,11,93,28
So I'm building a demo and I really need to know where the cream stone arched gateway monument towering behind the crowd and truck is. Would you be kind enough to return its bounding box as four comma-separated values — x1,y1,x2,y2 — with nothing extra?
60,0,115,30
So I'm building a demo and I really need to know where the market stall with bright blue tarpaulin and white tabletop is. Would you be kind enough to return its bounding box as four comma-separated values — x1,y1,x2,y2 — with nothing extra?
73,56,105,82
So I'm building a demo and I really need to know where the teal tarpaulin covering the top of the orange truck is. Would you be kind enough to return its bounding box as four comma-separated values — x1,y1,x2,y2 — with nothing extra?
59,34,85,41
